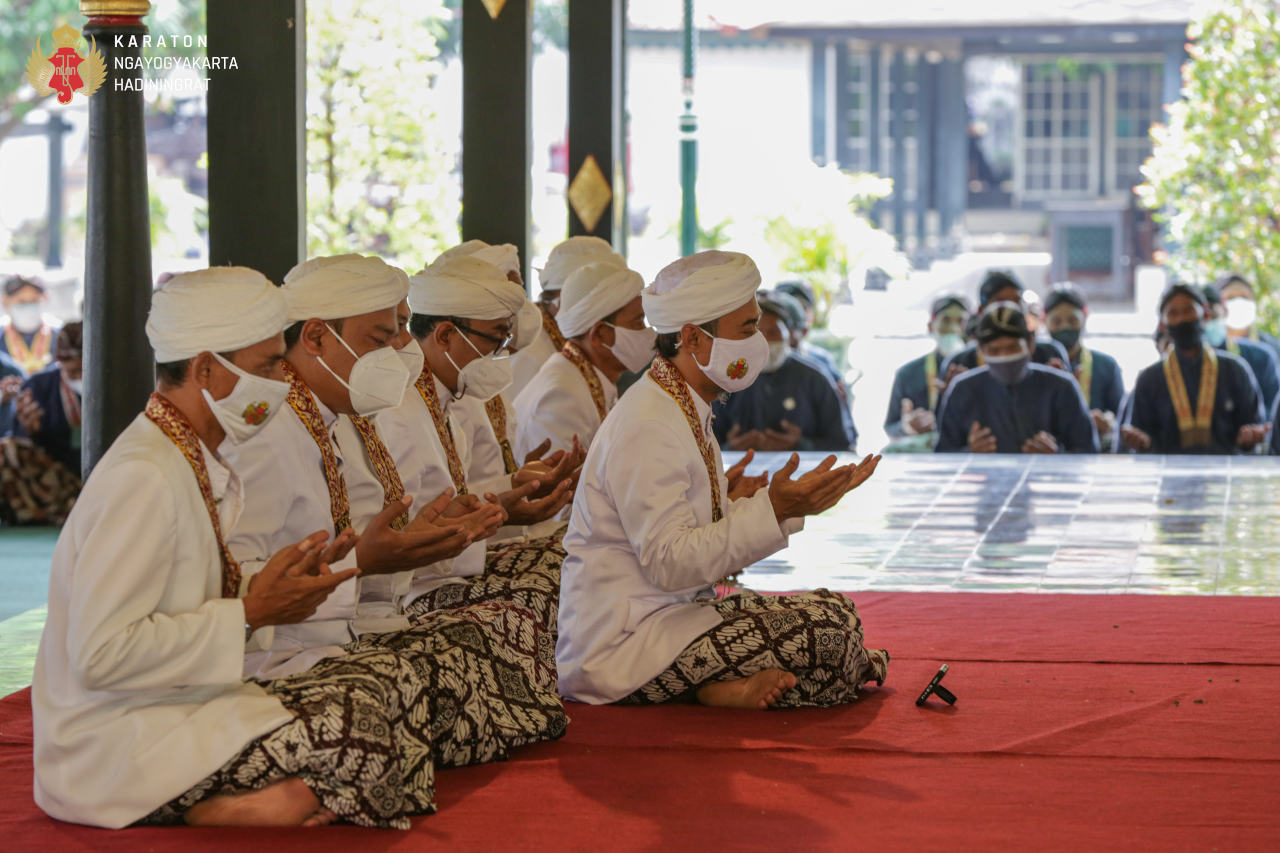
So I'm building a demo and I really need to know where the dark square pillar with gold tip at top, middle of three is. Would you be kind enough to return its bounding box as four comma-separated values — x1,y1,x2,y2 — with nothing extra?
460,0,532,282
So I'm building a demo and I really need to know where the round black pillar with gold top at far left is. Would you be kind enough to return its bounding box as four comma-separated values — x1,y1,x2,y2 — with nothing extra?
81,0,155,476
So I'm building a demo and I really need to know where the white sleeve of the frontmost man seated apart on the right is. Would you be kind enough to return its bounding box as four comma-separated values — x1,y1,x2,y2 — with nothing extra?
605,421,787,592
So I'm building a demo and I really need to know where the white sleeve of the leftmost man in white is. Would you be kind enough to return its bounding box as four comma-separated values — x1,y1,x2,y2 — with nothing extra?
67,460,244,690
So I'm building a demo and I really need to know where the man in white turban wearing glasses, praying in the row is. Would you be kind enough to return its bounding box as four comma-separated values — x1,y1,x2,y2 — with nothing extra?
381,249,582,635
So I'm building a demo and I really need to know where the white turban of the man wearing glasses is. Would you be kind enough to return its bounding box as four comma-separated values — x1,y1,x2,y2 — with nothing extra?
408,255,526,320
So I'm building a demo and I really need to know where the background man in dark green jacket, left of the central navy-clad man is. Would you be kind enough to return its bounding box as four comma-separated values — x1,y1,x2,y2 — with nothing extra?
884,293,969,438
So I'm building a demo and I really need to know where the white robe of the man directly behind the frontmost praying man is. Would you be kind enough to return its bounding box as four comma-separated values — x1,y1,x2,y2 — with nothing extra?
516,353,618,459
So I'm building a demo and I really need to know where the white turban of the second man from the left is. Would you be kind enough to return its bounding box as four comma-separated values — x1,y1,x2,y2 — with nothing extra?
280,255,408,323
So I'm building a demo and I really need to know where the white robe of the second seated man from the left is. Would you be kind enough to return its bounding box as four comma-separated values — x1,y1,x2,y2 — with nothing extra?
225,386,373,679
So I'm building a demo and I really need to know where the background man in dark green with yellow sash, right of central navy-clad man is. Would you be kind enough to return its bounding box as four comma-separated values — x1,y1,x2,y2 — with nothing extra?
1044,282,1124,450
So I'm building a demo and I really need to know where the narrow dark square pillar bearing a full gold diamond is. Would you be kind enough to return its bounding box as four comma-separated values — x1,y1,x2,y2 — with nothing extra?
568,0,627,252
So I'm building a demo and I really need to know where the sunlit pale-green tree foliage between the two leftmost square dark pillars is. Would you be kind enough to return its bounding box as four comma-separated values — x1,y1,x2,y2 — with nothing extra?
307,0,460,272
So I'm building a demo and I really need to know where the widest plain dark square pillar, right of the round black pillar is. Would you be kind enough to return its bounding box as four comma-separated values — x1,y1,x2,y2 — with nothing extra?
207,0,306,283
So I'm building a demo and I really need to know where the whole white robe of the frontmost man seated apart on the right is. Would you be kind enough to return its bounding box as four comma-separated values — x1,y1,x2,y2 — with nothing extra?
556,375,801,704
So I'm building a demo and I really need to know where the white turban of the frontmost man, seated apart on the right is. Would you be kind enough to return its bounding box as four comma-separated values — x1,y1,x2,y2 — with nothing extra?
641,251,760,334
